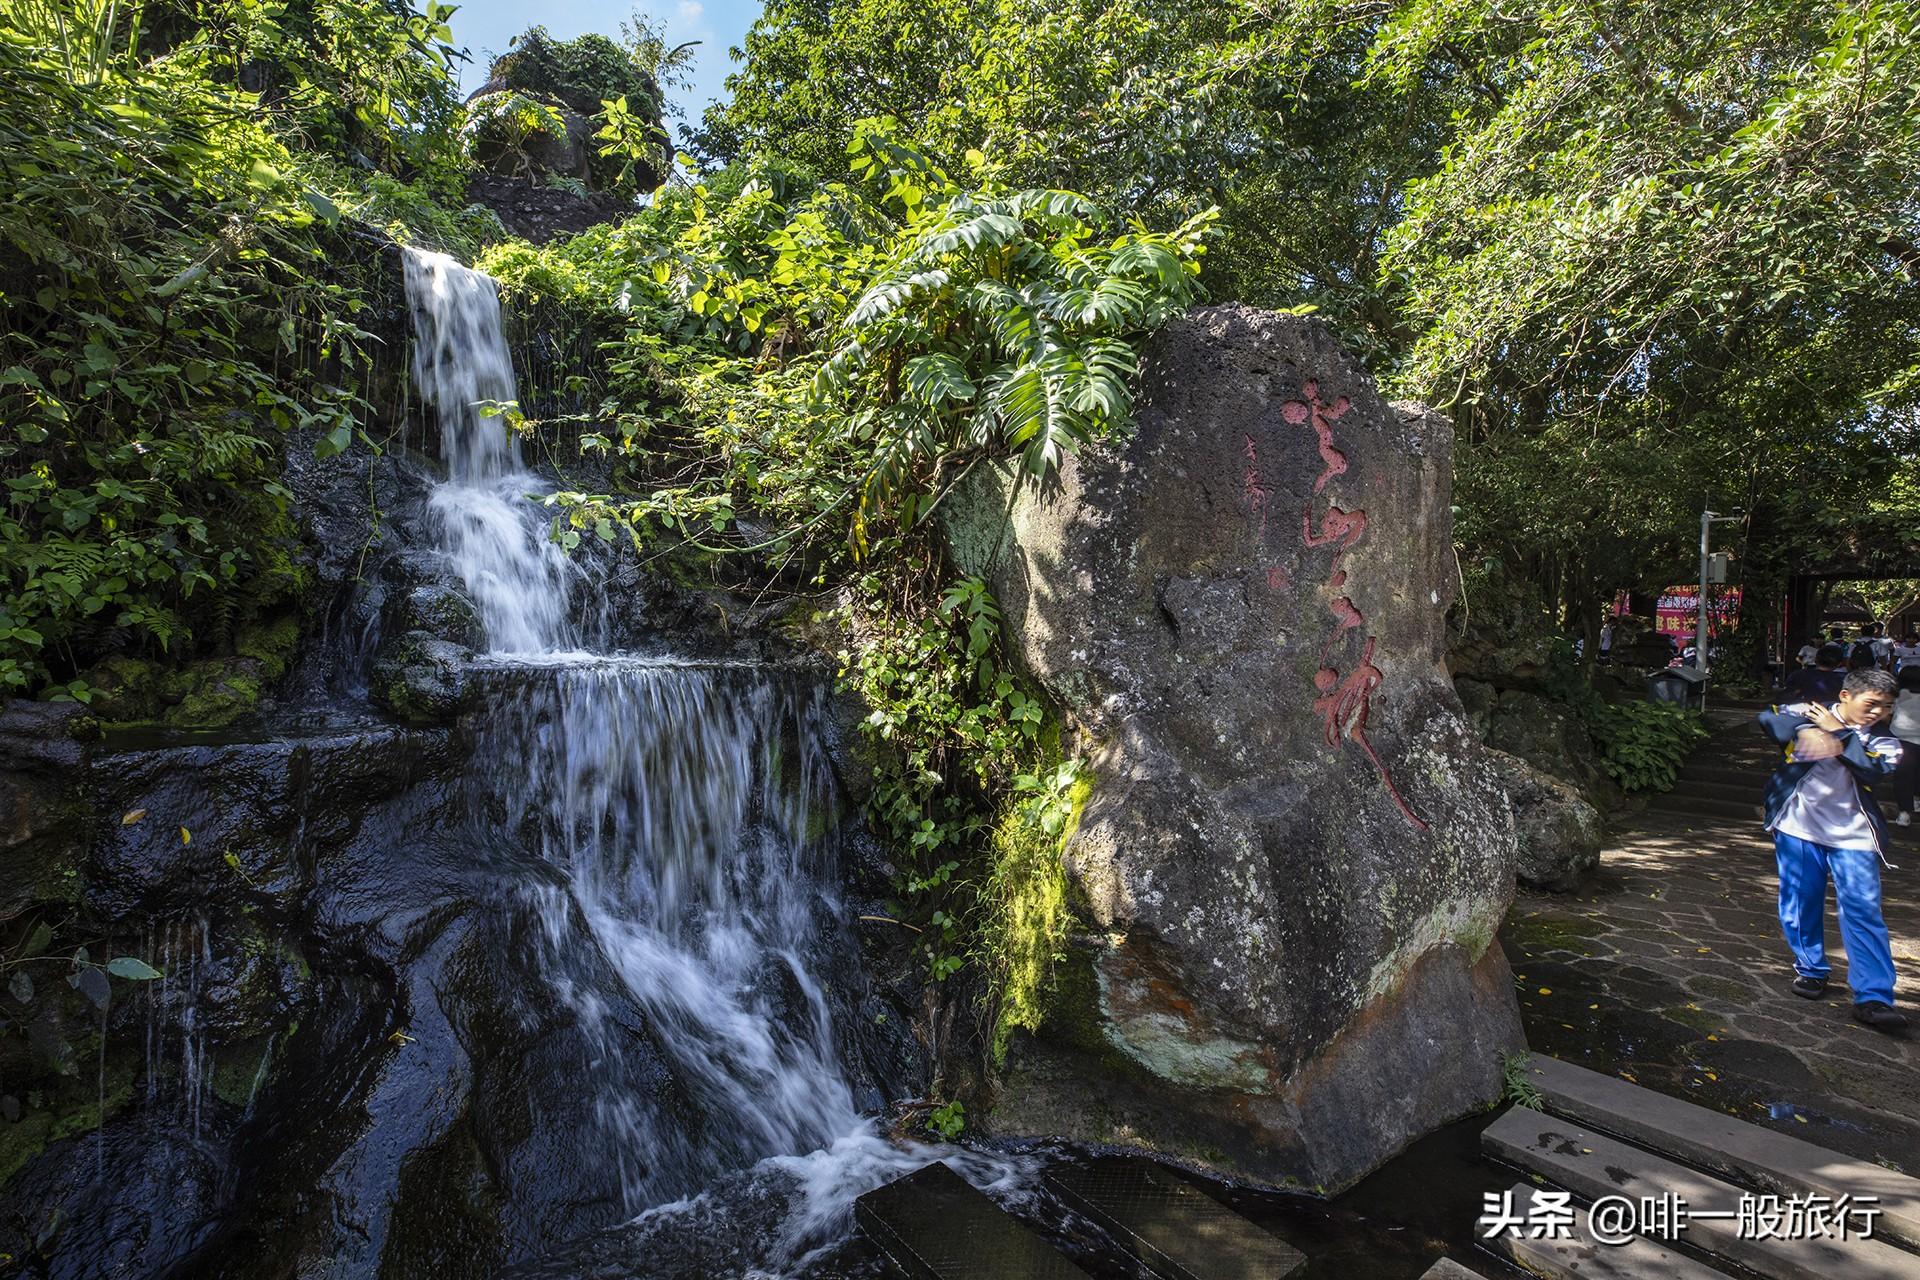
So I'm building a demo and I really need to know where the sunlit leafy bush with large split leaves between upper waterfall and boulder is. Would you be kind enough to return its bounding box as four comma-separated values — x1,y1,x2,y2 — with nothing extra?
484,121,1212,557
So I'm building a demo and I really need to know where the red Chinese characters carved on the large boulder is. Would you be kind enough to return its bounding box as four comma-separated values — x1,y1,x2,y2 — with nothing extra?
1242,380,1427,831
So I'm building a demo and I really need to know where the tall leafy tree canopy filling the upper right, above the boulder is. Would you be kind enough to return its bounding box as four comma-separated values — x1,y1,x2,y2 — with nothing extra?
703,0,1920,652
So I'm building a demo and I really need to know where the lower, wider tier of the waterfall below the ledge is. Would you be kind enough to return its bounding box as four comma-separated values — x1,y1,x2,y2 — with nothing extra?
480,660,860,1209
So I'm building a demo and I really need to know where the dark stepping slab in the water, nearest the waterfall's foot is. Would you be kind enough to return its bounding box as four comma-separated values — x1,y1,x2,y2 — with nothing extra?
852,1163,1091,1280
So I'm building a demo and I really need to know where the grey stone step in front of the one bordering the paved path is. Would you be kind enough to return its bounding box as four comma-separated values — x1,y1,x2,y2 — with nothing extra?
1480,1107,1920,1280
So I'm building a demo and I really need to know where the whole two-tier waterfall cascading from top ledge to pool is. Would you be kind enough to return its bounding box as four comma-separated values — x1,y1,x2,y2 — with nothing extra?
407,251,991,1265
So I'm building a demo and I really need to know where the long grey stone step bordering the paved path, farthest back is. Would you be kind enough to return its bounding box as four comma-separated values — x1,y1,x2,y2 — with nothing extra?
1526,1054,1920,1245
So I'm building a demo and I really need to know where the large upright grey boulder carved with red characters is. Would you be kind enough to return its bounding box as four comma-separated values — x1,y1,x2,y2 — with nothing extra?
948,307,1521,1190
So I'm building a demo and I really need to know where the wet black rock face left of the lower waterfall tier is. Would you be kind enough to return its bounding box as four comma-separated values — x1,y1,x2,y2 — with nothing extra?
0,716,668,1278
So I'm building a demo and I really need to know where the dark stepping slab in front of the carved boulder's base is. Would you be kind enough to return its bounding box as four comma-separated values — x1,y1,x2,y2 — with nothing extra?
1046,1161,1308,1280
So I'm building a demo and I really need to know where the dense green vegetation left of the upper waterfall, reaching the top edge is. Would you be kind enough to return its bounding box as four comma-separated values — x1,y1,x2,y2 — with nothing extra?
0,0,449,699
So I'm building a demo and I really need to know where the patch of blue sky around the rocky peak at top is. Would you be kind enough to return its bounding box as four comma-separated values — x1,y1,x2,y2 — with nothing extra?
451,0,760,142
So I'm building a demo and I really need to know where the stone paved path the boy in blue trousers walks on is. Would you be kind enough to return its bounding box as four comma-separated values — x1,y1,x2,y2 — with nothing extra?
1501,714,1920,1174
